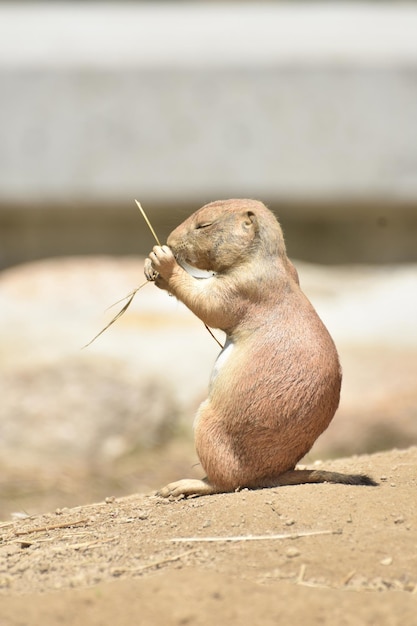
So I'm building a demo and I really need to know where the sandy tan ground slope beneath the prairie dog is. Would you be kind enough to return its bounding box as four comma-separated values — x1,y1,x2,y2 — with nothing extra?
0,447,417,626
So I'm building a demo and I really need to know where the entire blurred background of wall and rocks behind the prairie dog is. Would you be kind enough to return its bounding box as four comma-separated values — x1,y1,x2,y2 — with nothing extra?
0,0,417,516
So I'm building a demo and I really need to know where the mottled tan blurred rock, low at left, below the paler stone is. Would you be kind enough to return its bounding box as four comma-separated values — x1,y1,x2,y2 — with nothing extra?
0,358,178,466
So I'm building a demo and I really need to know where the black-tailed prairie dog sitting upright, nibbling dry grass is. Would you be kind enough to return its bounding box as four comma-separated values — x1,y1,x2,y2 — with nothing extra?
145,200,374,496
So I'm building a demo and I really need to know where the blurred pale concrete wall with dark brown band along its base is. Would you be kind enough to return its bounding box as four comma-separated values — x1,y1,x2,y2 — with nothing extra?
0,3,417,265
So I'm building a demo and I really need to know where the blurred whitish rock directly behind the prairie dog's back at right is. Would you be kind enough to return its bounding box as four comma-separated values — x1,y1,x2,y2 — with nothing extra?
296,261,417,350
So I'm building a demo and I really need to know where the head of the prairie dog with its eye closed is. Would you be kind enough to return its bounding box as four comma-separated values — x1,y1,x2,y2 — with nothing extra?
167,200,285,272
